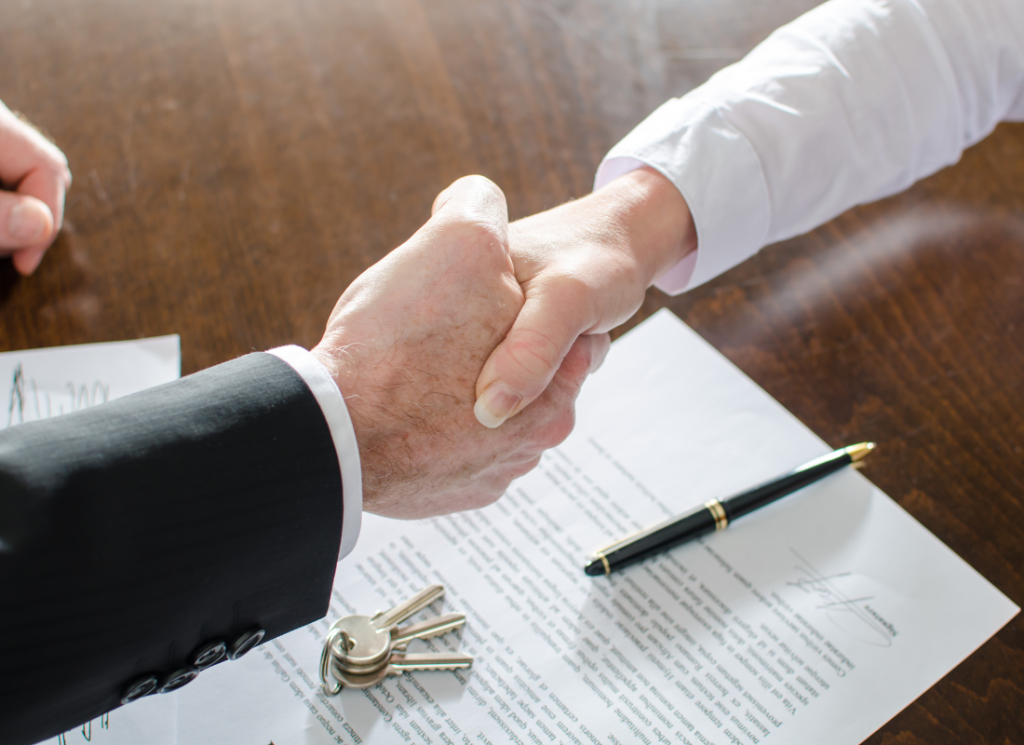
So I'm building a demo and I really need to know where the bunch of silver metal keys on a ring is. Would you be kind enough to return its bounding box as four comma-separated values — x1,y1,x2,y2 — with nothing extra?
321,584,473,696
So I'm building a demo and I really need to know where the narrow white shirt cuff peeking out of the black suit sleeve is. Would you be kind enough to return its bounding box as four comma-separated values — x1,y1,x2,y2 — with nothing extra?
267,346,362,561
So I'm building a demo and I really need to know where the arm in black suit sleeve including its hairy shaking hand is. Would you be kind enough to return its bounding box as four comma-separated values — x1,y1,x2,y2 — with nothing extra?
0,178,608,745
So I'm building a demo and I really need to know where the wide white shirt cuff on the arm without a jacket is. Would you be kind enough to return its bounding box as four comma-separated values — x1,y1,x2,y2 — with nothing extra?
594,96,771,295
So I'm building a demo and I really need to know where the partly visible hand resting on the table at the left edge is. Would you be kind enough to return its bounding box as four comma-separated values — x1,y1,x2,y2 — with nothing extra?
0,102,71,274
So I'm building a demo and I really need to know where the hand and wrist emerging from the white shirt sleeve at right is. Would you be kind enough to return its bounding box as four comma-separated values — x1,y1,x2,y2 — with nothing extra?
475,168,696,427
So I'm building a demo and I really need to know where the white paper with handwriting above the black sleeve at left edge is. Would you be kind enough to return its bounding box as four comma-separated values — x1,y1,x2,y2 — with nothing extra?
0,334,181,429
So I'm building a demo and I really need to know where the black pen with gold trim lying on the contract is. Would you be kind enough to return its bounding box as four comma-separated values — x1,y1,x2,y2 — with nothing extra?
584,442,874,577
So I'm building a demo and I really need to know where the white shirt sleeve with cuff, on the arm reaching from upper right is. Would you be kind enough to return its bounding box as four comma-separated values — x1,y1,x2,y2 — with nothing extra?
595,0,1024,293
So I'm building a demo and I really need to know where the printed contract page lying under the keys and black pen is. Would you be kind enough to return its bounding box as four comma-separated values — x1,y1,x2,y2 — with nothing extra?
69,311,1018,745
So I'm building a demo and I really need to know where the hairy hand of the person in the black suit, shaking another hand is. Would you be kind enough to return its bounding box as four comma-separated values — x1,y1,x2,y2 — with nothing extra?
312,176,608,518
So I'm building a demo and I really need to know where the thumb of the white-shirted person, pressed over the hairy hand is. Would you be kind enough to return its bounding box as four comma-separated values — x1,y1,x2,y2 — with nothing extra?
473,292,591,429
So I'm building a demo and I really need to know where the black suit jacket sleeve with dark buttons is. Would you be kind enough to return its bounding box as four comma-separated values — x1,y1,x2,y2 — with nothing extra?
0,354,343,745
